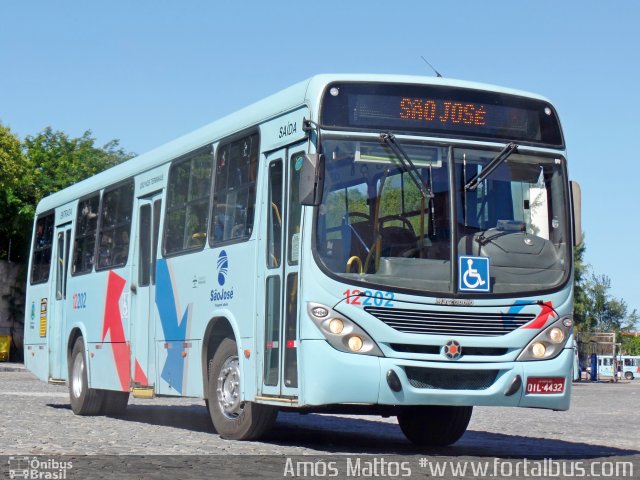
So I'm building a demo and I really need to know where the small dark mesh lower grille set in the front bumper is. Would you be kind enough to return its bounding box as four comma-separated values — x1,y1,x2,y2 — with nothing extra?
405,367,499,390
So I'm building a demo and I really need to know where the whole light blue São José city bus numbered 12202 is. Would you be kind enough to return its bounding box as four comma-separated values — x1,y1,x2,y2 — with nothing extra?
25,75,580,445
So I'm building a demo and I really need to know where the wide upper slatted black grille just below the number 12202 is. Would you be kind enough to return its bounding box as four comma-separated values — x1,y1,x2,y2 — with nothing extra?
365,307,535,337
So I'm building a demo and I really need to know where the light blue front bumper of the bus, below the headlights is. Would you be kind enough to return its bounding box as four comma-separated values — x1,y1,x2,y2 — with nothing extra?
299,340,573,410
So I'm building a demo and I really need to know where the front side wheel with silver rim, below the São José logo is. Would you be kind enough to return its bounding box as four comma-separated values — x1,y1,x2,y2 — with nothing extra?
207,338,278,440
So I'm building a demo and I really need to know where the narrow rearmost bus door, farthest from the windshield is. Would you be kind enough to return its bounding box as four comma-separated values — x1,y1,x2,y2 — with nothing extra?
47,223,71,380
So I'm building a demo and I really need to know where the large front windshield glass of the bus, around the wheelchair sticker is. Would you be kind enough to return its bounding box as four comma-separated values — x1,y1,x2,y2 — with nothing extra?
315,138,570,295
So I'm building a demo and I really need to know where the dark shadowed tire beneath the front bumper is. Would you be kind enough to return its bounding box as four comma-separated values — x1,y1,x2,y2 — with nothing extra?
398,405,473,446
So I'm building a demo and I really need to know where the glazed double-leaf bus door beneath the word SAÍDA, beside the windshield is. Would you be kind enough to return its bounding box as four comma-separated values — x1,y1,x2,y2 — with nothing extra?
257,143,306,402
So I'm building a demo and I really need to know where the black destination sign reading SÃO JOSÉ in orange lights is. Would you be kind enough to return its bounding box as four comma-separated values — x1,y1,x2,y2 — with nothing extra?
321,83,563,147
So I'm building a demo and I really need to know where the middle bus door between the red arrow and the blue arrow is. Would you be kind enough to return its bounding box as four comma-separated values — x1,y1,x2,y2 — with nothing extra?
131,193,162,387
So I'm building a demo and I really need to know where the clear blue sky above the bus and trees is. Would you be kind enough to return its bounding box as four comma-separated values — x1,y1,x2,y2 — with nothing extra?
0,0,640,318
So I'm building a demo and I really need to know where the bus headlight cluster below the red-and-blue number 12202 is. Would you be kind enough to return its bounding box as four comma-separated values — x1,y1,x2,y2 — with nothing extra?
307,303,384,357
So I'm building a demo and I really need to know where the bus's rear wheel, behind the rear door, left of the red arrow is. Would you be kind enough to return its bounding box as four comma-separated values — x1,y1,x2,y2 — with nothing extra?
69,337,104,415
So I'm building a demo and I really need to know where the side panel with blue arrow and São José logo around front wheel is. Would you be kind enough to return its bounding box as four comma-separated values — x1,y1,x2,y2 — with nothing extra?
156,240,256,397
